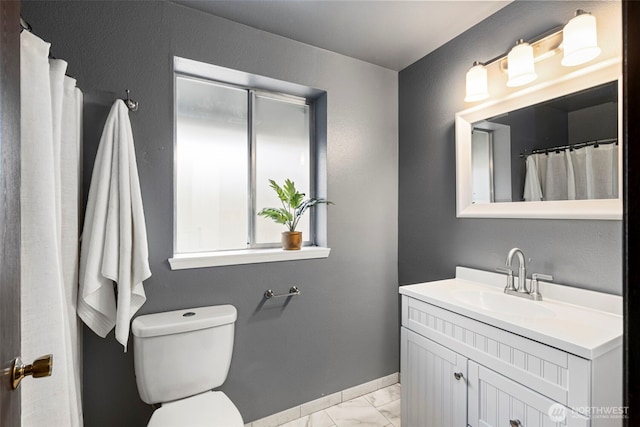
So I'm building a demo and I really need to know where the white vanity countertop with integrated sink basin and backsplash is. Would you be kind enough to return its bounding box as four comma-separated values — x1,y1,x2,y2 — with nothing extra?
400,267,622,359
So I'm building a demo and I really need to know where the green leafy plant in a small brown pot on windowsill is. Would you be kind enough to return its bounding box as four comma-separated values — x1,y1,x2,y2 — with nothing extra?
258,179,333,250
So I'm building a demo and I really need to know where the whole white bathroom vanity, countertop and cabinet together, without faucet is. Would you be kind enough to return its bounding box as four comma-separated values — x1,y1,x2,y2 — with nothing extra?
400,267,625,427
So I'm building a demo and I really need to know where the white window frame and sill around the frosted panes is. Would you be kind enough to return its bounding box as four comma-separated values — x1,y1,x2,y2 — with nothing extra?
168,57,330,270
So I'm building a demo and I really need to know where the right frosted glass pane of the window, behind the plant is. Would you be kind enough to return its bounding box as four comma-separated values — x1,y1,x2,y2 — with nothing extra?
254,96,311,244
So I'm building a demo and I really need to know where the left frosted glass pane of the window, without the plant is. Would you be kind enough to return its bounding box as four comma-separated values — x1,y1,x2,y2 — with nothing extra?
175,77,249,253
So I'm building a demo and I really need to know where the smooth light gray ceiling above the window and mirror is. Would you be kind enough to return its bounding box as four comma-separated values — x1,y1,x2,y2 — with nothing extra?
174,0,510,71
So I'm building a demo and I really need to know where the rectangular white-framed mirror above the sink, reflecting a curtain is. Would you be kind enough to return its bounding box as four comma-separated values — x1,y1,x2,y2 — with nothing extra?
455,59,622,220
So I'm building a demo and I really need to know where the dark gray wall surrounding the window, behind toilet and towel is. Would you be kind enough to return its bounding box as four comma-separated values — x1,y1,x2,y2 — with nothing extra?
22,1,399,427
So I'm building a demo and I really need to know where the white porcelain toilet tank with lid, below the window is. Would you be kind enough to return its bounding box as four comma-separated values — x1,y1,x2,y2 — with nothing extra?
131,305,237,404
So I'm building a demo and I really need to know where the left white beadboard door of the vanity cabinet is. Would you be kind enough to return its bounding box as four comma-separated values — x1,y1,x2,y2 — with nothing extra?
400,327,467,427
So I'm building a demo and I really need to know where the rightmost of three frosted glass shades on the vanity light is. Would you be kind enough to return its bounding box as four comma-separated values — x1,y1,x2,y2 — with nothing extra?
562,10,601,67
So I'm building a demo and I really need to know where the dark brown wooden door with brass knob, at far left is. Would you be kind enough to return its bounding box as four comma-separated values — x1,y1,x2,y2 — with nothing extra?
0,1,20,427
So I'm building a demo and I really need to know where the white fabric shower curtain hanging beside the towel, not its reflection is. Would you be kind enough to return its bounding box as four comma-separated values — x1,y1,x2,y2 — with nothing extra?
20,31,83,427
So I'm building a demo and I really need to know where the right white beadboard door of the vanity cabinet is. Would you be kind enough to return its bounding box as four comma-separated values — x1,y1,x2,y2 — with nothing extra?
464,361,589,427
